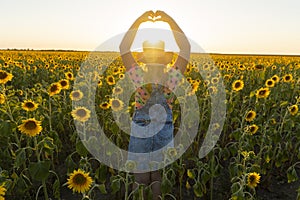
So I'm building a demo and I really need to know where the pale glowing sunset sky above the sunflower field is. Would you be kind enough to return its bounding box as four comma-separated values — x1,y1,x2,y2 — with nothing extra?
0,0,300,55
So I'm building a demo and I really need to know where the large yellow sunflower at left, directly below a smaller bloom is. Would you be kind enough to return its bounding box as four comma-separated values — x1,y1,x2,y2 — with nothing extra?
18,118,43,137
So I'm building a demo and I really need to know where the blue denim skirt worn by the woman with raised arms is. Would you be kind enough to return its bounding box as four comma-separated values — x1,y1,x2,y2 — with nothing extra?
127,94,174,170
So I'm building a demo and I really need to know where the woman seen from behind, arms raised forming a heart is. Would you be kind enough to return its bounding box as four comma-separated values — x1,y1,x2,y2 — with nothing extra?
120,11,190,199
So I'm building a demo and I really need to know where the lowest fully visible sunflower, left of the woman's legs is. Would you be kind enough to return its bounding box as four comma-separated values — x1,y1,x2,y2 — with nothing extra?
67,169,93,193
